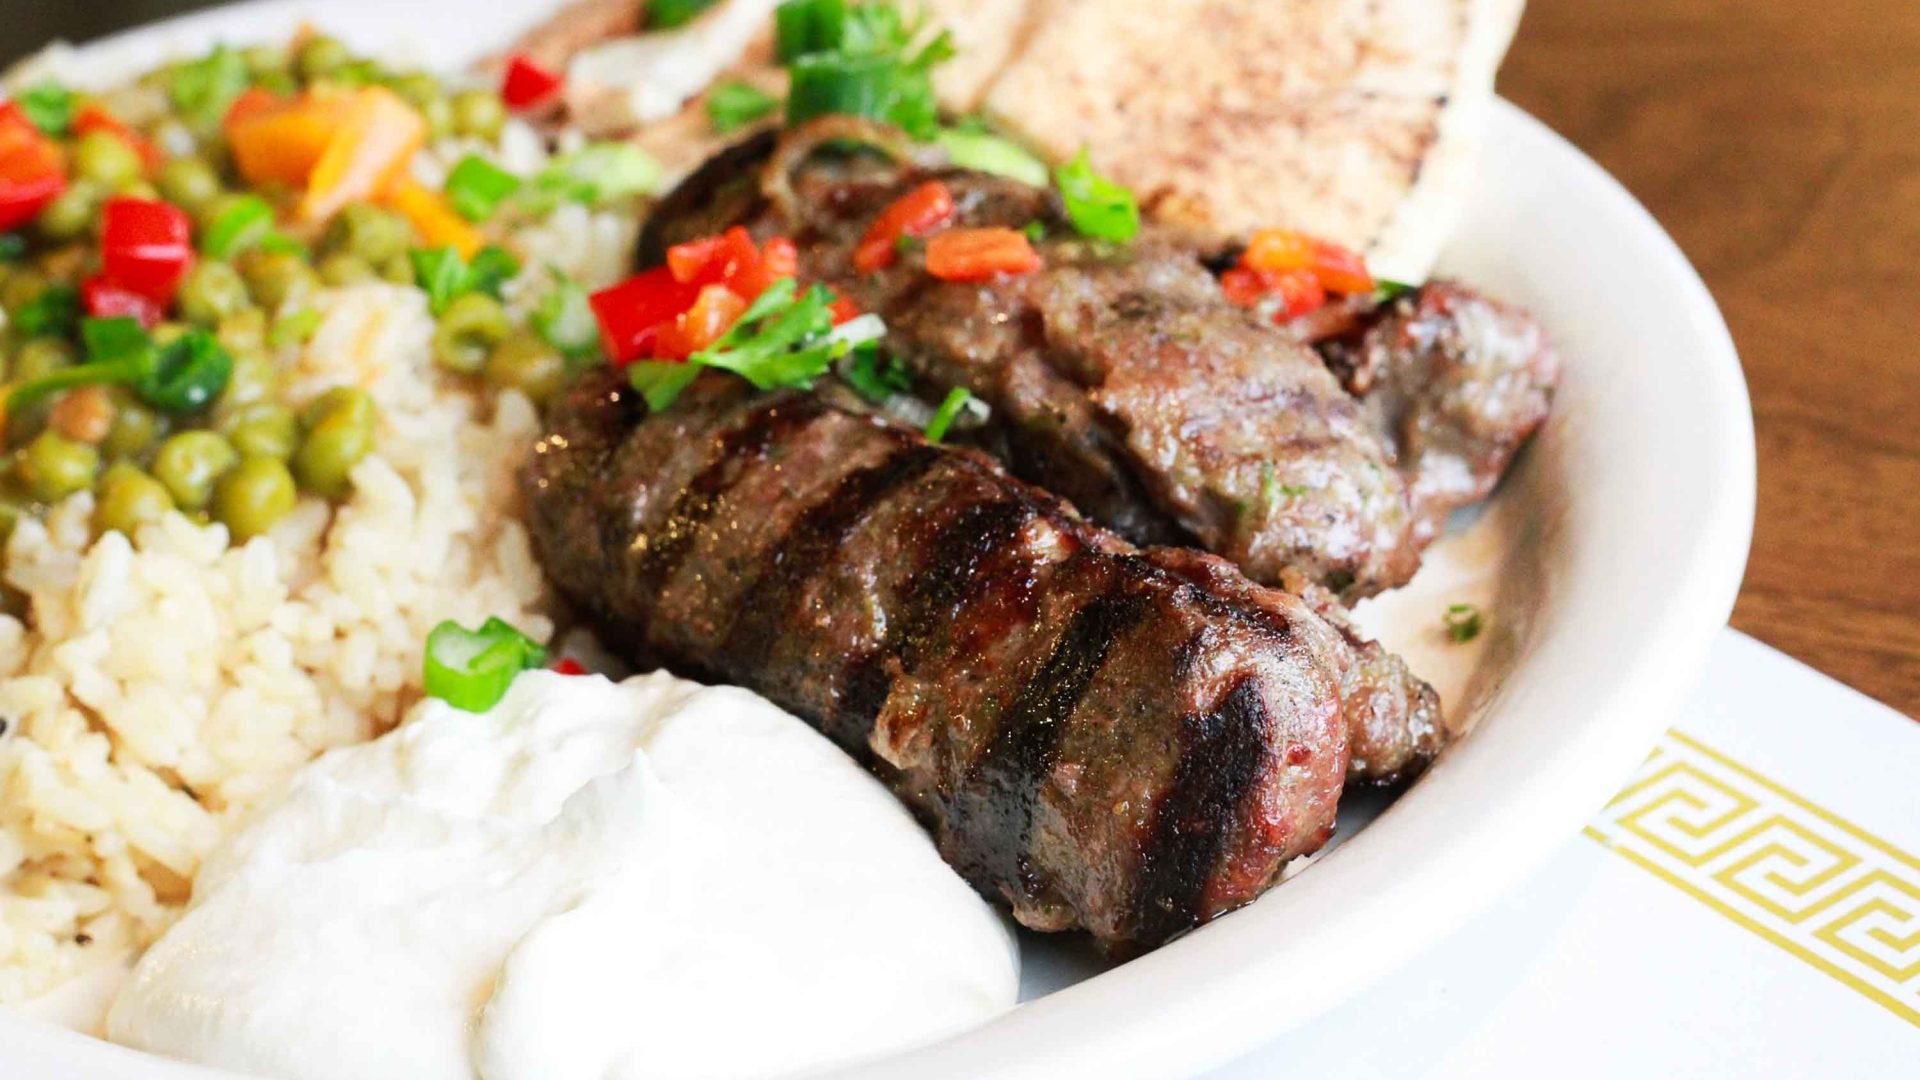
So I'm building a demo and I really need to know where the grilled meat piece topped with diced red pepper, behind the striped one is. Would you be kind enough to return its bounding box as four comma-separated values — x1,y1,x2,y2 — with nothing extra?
641,121,1419,596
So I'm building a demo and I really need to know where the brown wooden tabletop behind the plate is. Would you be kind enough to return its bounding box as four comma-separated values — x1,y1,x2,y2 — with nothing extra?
11,0,1920,715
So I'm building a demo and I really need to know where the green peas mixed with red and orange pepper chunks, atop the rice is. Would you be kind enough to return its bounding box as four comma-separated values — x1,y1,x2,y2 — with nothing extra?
0,31,659,542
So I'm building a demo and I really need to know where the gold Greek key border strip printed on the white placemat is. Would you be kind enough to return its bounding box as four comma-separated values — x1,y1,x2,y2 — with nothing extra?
1586,730,1920,1026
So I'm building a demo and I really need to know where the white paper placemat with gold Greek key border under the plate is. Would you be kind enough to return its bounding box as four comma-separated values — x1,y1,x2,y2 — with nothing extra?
1210,630,1920,1080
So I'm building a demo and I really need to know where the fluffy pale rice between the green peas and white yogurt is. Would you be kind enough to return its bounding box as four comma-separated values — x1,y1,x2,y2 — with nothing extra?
0,189,632,1001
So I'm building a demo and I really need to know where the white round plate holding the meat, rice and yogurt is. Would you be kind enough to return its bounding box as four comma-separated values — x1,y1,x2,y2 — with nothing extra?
0,0,1753,1080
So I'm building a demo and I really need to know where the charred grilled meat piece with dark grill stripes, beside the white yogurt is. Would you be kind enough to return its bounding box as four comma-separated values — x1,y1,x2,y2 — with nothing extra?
524,373,1432,951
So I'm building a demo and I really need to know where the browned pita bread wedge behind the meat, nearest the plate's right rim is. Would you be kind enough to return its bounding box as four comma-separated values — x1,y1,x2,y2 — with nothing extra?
967,0,1523,281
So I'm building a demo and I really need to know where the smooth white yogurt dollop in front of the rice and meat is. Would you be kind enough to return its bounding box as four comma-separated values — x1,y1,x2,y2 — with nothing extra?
108,673,1018,1080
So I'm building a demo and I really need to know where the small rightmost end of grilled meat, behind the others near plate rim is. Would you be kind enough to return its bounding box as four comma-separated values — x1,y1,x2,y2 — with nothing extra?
1319,281,1559,546
